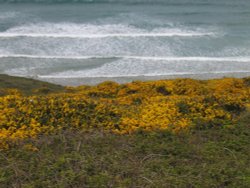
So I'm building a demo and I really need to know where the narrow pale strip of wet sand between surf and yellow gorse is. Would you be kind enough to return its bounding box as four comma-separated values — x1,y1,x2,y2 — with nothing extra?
0,72,250,87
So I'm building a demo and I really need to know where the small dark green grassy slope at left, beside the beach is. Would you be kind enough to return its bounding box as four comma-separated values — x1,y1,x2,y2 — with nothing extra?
0,74,63,94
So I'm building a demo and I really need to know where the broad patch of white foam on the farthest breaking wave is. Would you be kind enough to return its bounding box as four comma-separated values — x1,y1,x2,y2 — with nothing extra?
0,23,215,38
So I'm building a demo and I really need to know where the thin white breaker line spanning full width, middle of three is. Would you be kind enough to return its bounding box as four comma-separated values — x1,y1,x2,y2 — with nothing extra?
0,54,250,63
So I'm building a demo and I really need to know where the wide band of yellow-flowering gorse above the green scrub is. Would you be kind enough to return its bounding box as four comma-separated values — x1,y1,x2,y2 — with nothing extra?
0,78,250,148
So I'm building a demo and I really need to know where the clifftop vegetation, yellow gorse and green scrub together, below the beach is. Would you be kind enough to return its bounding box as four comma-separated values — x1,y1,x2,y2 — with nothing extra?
0,74,250,188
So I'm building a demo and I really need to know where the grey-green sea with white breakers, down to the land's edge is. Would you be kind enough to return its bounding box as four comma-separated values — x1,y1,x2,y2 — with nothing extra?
0,0,250,85
